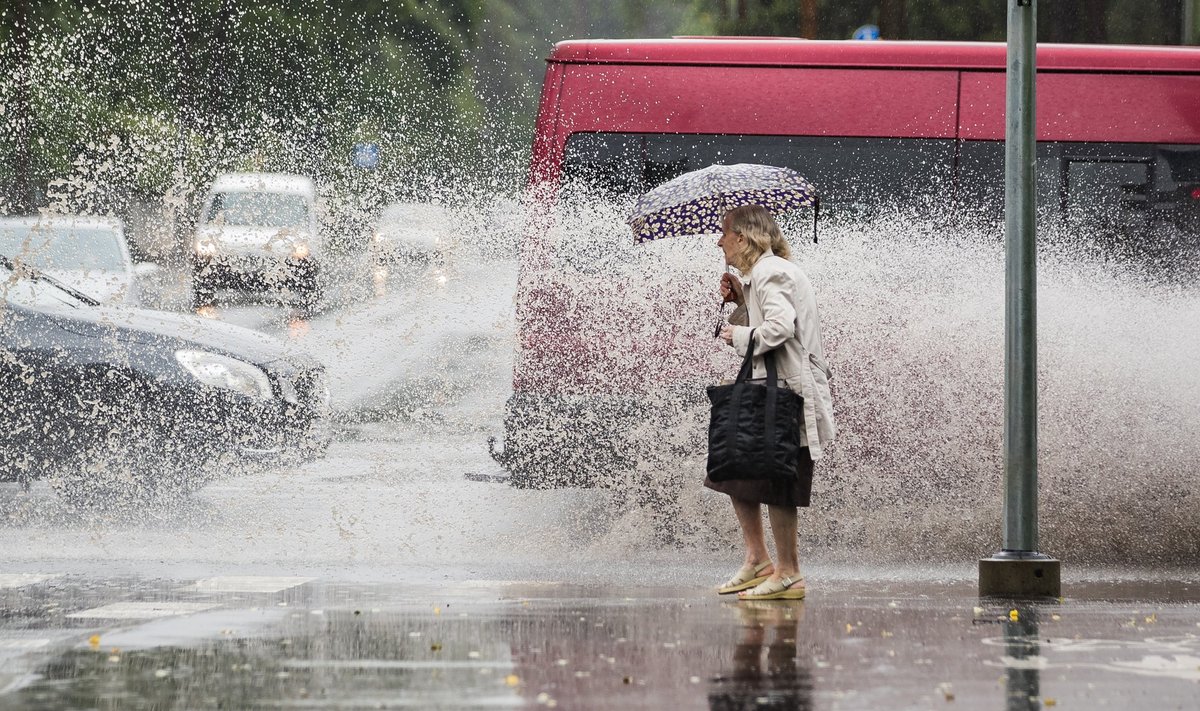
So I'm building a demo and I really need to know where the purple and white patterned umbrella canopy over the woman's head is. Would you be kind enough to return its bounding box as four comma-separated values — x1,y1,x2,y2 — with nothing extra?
629,163,817,243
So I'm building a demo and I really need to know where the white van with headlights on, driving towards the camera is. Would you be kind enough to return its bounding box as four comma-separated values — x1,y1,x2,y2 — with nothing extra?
192,173,326,305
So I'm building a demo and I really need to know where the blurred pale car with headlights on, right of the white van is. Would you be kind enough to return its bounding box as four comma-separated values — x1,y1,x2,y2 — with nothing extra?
371,203,455,267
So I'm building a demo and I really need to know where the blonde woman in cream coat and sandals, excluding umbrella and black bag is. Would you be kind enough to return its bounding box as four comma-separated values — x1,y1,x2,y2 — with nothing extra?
704,205,835,599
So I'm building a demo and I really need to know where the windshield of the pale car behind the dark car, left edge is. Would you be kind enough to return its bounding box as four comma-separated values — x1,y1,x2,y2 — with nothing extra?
0,222,127,271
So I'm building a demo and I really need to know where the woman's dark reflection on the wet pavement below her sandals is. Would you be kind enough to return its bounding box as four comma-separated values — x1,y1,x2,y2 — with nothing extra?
708,601,812,711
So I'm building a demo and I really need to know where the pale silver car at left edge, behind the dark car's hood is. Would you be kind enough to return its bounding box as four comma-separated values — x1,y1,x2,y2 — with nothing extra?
0,215,158,304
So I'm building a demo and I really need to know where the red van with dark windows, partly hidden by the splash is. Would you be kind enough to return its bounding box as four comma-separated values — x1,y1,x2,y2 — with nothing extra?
494,38,1200,486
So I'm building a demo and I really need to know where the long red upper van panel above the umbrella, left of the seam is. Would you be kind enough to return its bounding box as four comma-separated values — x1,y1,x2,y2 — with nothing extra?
549,65,958,145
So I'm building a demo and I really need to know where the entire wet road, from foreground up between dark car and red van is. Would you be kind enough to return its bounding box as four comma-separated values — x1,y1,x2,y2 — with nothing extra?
7,230,1200,711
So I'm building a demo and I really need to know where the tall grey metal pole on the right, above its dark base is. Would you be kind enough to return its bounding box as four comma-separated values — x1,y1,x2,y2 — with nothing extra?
1004,0,1038,551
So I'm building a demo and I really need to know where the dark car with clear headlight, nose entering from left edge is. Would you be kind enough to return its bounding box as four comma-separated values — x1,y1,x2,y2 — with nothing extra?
0,256,329,502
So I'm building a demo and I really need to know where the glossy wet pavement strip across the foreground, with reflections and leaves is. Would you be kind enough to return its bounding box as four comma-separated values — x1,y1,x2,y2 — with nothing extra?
0,574,1200,710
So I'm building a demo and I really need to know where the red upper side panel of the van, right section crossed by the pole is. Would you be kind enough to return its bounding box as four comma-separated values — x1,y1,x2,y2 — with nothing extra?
960,72,1200,143
